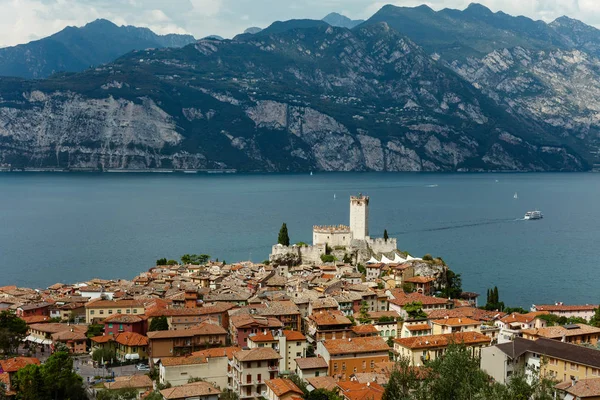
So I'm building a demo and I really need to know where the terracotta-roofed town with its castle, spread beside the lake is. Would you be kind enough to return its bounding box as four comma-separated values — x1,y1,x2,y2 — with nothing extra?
0,195,600,400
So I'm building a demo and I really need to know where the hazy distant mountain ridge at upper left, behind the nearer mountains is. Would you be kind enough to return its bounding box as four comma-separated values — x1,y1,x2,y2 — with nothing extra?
0,19,195,79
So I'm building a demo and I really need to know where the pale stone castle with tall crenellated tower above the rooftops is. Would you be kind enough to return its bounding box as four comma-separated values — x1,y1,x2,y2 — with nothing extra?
269,194,398,264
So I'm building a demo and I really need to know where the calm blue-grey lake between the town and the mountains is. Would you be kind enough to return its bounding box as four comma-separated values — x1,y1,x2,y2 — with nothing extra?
0,173,600,307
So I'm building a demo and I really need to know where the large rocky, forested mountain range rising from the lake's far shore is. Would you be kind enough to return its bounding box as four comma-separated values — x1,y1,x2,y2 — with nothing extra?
0,4,600,171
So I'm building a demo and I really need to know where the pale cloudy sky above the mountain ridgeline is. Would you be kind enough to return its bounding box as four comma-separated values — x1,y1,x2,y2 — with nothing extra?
0,0,600,47
